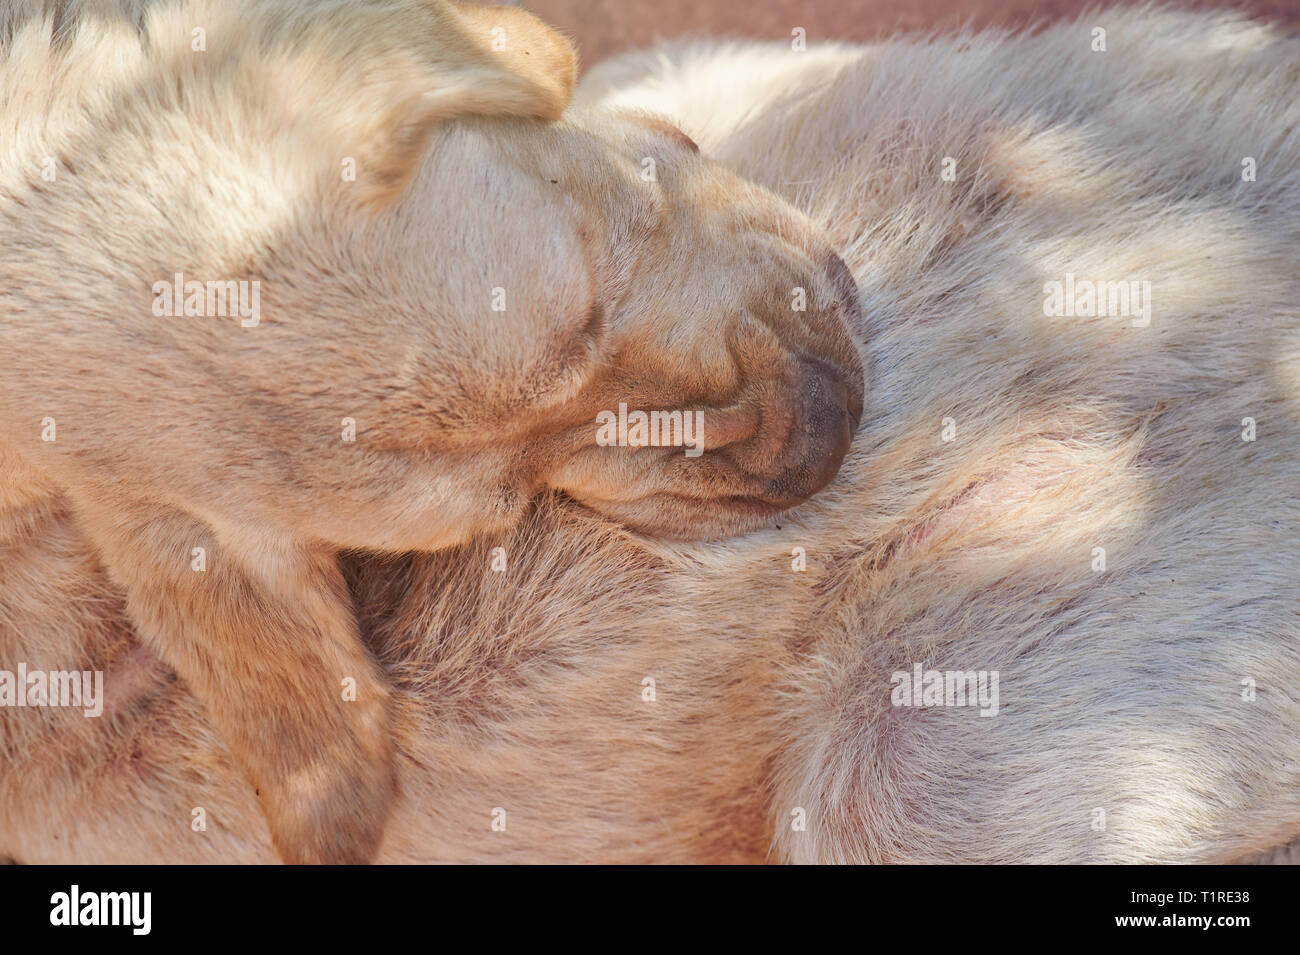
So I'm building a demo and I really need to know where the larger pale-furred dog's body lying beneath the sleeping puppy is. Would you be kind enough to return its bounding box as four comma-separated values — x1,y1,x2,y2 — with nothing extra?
0,1,1300,861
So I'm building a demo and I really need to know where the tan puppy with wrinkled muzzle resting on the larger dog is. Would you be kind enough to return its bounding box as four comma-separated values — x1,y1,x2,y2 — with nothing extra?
0,0,862,861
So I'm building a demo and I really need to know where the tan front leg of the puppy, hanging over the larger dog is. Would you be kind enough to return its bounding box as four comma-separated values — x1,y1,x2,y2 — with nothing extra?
69,498,394,863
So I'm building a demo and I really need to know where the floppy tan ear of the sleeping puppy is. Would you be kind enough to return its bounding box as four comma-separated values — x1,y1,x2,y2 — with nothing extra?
322,0,577,207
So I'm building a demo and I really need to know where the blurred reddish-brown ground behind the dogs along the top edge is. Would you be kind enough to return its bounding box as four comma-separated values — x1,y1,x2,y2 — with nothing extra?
525,0,1300,66
